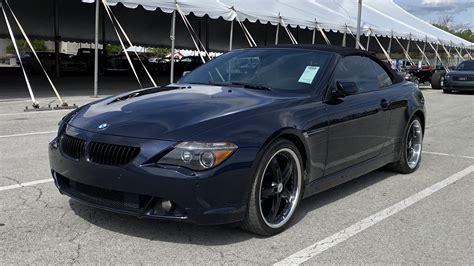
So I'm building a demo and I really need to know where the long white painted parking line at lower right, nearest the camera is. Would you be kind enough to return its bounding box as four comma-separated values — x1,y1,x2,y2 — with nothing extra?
275,164,474,265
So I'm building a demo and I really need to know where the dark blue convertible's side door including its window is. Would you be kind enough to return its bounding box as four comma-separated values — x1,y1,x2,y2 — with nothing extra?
324,56,390,175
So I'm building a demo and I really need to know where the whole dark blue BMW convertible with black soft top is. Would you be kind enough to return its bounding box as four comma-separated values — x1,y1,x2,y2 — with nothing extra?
49,45,425,235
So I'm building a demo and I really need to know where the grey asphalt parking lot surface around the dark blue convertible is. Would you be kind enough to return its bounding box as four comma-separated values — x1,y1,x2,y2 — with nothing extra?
0,89,474,264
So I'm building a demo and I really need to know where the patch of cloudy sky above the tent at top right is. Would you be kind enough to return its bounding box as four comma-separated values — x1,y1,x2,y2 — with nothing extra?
394,0,474,30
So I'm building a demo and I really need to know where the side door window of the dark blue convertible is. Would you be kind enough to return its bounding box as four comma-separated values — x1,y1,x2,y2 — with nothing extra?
335,56,383,93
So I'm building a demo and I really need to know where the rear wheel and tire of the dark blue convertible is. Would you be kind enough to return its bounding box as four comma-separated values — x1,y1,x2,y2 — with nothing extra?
388,116,423,174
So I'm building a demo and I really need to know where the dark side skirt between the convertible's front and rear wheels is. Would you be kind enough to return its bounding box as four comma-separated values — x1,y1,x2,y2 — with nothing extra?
303,153,398,198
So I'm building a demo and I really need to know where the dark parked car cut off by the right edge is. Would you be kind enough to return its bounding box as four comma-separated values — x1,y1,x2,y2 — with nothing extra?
442,60,474,93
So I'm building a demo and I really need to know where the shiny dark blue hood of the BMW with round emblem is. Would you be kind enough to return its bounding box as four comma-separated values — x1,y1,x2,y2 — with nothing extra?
69,84,291,141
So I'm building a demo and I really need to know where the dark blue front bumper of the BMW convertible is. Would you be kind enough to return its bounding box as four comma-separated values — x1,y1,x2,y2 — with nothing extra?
49,126,258,224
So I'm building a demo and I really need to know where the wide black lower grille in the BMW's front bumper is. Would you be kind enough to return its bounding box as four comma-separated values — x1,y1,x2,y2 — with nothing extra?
56,173,152,212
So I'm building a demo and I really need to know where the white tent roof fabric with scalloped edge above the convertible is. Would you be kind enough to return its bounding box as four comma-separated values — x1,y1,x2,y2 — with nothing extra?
83,0,473,47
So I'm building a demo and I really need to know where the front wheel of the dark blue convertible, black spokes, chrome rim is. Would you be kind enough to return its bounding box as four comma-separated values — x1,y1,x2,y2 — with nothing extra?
241,139,304,236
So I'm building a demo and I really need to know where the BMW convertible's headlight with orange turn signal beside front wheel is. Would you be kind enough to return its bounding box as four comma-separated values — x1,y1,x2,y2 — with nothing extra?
158,142,237,171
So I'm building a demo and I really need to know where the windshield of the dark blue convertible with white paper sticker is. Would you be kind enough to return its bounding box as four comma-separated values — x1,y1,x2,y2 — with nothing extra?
178,48,332,91
